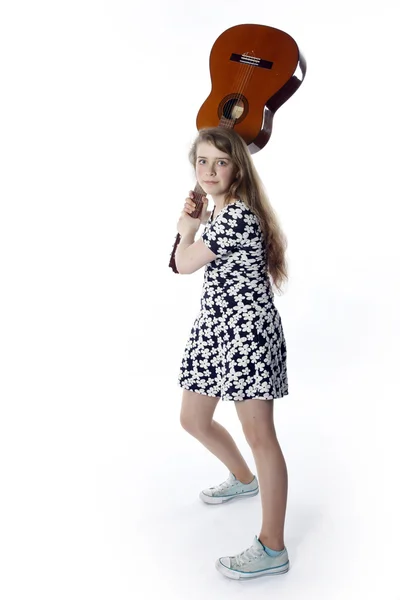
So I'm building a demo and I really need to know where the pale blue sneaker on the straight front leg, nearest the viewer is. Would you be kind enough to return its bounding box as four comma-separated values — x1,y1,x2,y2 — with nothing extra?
215,536,289,579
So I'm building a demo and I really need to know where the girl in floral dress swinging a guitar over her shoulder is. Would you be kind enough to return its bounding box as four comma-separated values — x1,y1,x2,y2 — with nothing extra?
175,127,289,579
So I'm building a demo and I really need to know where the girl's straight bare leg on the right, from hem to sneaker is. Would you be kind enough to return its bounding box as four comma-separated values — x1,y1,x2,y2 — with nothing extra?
235,399,288,550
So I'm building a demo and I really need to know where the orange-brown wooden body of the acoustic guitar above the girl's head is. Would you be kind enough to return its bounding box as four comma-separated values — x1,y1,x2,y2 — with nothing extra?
196,25,306,154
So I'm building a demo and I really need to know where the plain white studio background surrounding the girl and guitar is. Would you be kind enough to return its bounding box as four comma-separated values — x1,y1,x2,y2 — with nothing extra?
0,0,400,600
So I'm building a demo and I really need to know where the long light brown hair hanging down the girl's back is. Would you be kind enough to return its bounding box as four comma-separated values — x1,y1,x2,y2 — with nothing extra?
189,127,288,292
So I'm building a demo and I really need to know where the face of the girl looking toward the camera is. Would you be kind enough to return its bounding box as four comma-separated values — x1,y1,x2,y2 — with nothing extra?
196,142,236,201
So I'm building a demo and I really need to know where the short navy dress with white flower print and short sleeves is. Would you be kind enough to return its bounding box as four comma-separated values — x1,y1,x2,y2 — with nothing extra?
178,199,289,402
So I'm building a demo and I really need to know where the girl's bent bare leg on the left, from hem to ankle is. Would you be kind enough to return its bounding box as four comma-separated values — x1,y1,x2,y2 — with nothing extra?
181,390,254,483
